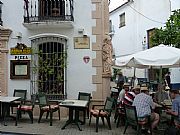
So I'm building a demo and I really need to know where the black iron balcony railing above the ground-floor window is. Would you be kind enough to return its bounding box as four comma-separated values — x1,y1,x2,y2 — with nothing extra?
24,0,74,23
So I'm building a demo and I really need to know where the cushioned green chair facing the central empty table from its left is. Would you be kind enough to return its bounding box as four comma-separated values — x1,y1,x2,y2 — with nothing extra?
38,93,60,126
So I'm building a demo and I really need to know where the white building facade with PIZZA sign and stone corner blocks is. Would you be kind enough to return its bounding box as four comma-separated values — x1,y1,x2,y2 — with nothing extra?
0,0,110,99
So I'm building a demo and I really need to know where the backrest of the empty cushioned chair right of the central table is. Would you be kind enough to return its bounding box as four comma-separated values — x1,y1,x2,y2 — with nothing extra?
104,97,114,115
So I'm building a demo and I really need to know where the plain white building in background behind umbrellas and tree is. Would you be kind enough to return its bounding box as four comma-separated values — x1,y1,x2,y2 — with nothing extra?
110,0,180,87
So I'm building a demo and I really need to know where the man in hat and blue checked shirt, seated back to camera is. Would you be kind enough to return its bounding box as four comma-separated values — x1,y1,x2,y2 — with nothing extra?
132,87,159,129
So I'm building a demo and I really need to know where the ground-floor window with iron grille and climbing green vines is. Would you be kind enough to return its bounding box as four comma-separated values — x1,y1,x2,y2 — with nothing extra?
31,37,67,99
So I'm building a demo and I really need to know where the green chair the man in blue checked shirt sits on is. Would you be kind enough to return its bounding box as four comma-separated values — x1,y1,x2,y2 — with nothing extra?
124,104,152,135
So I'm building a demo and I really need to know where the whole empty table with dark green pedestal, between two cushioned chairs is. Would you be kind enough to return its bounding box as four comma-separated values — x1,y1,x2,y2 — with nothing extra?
59,99,88,131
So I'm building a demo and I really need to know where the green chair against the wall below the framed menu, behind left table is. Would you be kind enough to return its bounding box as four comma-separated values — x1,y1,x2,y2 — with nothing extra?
10,89,27,114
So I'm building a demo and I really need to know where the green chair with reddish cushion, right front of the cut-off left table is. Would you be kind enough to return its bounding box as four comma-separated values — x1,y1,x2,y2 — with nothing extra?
15,95,35,126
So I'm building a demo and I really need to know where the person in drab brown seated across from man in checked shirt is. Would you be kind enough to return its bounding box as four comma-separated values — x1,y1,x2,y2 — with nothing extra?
153,83,170,104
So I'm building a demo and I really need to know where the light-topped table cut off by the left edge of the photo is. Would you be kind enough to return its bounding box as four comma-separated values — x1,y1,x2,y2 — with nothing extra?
0,96,21,126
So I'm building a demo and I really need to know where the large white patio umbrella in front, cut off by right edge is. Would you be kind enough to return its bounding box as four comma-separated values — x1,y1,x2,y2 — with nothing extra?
133,45,180,68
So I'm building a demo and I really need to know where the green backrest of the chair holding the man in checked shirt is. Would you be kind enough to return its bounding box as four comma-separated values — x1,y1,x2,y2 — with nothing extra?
124,104,138,125
